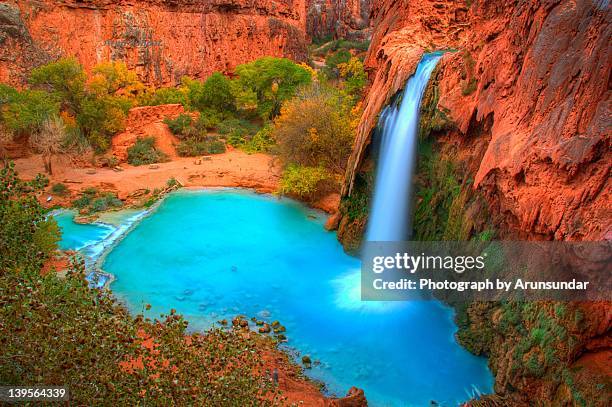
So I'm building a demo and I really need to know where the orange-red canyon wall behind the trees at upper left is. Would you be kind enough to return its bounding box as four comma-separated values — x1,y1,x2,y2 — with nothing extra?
0,0,307,85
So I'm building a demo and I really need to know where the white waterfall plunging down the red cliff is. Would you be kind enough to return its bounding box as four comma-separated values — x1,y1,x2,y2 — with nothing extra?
366,53,442,242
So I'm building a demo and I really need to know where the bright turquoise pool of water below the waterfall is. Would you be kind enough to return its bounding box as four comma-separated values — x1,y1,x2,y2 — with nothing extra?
52,190,492,406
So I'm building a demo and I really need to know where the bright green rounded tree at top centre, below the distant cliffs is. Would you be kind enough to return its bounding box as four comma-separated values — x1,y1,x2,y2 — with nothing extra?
232,57,312,119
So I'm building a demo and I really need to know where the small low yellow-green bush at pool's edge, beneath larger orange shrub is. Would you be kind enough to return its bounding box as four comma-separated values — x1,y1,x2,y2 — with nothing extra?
280,164,333,201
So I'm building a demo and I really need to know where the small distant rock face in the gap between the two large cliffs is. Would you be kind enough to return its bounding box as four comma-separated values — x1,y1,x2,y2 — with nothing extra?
306,0,373,40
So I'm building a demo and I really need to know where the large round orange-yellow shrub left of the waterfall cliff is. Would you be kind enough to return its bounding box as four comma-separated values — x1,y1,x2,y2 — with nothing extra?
273,86,356,174
